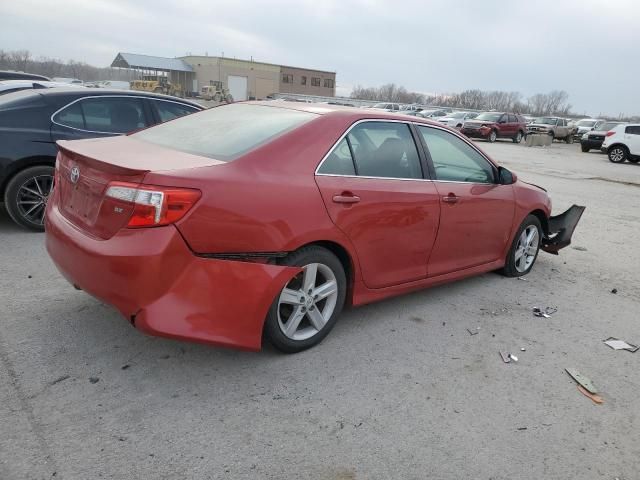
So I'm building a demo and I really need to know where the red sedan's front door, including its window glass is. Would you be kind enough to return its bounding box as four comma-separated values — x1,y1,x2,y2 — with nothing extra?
418,127,515,276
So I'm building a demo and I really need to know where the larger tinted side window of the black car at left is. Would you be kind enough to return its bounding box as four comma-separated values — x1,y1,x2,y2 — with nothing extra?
53,97,147,133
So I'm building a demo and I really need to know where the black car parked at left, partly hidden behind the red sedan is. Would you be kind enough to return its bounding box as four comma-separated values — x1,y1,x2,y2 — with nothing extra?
0,87,204,230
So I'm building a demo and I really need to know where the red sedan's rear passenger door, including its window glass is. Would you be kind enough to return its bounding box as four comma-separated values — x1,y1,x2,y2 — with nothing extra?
316,121,440,288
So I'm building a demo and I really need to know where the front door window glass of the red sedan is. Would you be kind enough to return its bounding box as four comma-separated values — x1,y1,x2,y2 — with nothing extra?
418,127,494,183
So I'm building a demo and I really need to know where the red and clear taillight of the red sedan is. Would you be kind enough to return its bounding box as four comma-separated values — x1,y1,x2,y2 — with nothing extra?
105,182,201,228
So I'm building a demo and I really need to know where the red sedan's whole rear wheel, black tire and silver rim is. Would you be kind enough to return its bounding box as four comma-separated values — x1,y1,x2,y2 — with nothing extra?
264,246,347,353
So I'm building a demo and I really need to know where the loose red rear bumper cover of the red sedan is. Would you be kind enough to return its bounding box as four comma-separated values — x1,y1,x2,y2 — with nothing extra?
46,202,298,350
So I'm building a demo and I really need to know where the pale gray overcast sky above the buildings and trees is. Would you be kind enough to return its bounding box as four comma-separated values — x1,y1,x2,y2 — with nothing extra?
0,0,640,115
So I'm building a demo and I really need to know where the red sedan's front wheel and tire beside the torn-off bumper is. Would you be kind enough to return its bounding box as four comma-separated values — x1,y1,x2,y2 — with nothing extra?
500,215,542,277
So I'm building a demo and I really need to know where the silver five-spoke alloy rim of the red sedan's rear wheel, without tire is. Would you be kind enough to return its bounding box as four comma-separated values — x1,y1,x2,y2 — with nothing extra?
278,263,338,340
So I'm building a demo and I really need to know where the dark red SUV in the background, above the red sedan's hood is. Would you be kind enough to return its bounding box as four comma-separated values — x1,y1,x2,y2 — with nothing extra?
460,112,527,143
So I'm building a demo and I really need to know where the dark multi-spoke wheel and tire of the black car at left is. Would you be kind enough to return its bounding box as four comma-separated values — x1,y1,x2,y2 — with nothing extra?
4,165,54,232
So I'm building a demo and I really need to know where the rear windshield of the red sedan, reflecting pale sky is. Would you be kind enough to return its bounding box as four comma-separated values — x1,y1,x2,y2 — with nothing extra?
131,103,317,162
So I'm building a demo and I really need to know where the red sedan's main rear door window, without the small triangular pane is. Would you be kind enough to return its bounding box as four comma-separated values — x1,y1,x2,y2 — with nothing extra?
347,122,422,178
